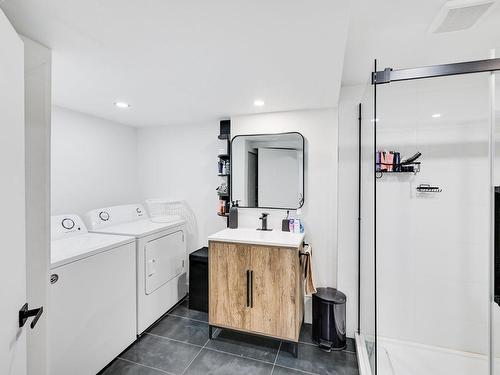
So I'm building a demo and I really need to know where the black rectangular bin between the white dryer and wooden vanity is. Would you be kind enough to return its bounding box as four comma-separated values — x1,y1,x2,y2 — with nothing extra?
189,247,208,313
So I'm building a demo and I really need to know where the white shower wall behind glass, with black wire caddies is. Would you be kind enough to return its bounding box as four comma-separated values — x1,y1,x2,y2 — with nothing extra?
376,74,490,354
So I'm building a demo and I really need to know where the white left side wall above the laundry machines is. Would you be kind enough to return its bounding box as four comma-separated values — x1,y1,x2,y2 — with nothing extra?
51,107,140,215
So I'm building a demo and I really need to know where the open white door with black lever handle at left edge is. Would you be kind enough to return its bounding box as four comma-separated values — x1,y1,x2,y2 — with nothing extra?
0,10,28,375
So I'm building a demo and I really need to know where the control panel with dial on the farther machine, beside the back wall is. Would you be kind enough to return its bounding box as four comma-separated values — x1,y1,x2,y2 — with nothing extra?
85,204,149,230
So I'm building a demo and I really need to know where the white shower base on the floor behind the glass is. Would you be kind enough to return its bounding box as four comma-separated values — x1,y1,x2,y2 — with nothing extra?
358,336,489,375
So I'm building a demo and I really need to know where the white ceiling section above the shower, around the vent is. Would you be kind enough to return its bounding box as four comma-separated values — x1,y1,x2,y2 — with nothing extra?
342,0,500,85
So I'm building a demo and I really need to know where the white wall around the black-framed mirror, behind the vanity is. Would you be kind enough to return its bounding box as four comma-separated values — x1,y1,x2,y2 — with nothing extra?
231,109,338,320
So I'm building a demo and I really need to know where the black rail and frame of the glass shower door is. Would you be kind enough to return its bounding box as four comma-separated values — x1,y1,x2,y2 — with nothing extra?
358,57,500,375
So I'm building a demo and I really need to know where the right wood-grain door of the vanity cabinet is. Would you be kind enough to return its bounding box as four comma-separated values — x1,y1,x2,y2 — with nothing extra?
251,245,302,341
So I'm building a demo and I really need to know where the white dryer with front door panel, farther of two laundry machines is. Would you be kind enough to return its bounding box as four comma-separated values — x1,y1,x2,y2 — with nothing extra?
86,204,187,335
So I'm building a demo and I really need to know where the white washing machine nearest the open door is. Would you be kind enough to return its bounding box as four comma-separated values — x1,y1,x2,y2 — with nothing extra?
47,215,136,375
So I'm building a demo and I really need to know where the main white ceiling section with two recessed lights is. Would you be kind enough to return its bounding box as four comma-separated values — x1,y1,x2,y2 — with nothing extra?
0,0,348,126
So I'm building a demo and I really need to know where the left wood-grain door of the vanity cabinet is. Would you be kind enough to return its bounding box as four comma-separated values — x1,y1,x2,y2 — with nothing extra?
208,242,250,330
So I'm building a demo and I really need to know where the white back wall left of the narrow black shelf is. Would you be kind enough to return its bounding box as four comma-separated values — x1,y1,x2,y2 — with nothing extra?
137,121,226,252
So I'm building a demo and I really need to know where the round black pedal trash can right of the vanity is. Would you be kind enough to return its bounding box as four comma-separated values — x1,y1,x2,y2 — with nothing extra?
312,288,347,351
